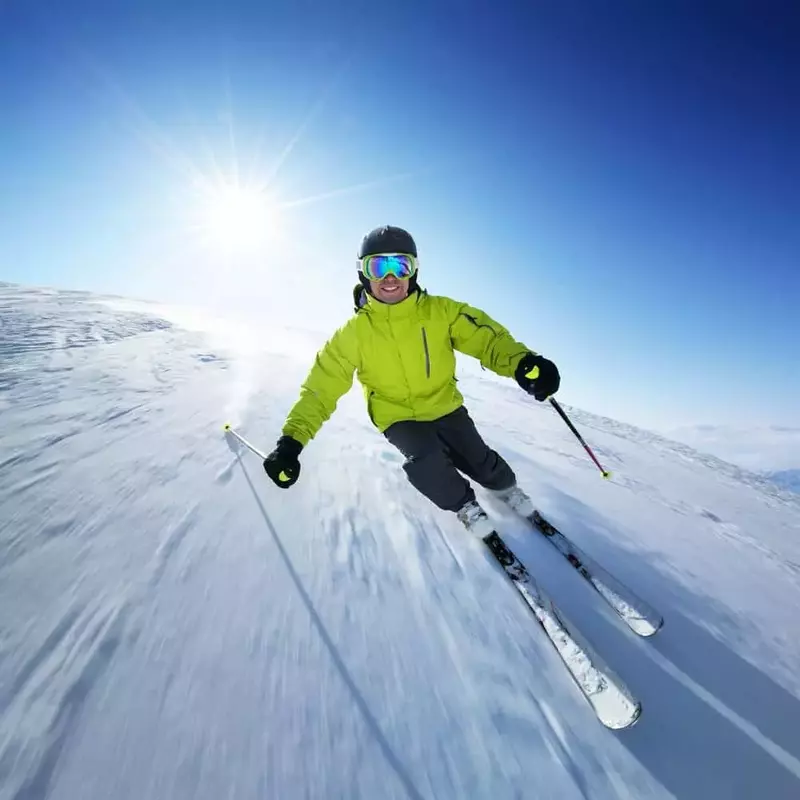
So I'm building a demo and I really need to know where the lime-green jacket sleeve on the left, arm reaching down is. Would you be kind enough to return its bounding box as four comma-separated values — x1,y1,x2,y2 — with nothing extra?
283,325,358,446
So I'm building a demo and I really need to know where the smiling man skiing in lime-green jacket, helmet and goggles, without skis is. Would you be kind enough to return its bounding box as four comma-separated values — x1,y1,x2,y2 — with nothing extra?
264,226,560,538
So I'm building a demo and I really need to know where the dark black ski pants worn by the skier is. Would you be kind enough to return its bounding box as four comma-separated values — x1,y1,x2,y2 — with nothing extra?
384,406,516,511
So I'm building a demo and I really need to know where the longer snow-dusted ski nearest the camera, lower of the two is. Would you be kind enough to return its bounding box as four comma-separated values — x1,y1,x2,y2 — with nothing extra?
483,532,642,730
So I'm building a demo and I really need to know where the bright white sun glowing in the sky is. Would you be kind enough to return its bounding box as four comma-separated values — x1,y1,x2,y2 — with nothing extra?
200,184,279,252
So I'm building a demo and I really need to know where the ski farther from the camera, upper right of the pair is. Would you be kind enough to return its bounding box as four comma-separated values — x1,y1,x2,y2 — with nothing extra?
526,511,664,636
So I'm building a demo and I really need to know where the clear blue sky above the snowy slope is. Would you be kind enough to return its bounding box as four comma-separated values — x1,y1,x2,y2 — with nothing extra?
0,0,800,429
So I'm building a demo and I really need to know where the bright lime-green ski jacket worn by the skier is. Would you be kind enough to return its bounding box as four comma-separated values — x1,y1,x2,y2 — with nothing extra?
283,291,533,446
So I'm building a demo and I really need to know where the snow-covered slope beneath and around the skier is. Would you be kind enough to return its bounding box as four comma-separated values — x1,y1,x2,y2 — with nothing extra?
0,284,800,800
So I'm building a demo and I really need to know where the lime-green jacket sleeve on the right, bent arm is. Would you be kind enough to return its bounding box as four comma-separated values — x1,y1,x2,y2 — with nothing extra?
445,298,534,378
